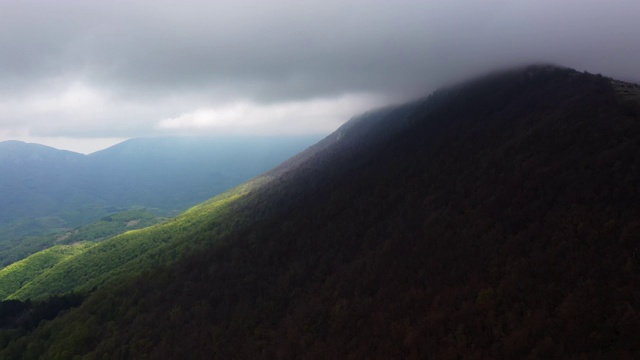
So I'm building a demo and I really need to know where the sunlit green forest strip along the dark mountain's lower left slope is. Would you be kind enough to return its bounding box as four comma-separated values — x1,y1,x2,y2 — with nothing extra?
11,177,267,300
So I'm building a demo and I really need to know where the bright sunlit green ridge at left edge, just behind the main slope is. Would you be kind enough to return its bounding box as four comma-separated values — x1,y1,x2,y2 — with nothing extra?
0,242,94,300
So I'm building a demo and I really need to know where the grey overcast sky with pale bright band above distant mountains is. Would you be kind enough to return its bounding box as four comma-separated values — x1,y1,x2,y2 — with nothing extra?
0,0,640,153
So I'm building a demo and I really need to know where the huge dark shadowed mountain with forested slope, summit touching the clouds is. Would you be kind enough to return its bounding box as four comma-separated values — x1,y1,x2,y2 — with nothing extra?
0,66,640,359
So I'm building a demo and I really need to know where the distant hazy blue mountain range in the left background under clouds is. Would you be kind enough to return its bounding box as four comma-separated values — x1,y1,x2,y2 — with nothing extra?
0,136,318,236
